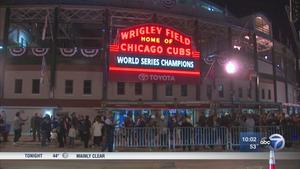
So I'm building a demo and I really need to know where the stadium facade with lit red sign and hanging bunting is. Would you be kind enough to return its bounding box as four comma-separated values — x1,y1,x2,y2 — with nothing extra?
0,0,300,131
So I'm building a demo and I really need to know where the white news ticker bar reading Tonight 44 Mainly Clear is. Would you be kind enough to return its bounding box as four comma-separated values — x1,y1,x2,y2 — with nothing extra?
0,152,300,160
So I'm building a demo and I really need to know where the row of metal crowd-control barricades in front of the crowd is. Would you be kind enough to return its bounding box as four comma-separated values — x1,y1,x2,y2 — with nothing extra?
114,126,300,151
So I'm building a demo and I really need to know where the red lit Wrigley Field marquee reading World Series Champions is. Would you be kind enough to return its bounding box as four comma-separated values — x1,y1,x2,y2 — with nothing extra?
109,24,200,83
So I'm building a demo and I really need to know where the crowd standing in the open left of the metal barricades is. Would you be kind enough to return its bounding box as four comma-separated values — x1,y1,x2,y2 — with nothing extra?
0,112,115,152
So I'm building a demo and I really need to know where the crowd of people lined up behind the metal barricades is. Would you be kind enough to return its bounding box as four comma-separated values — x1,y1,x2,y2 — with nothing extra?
124,112,300,128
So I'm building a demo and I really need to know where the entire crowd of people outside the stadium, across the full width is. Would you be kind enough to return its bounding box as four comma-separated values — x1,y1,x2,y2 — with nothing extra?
0,112,300,152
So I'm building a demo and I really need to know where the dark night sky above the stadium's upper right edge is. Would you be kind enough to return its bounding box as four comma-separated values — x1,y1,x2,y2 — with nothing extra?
210,0,300,43
